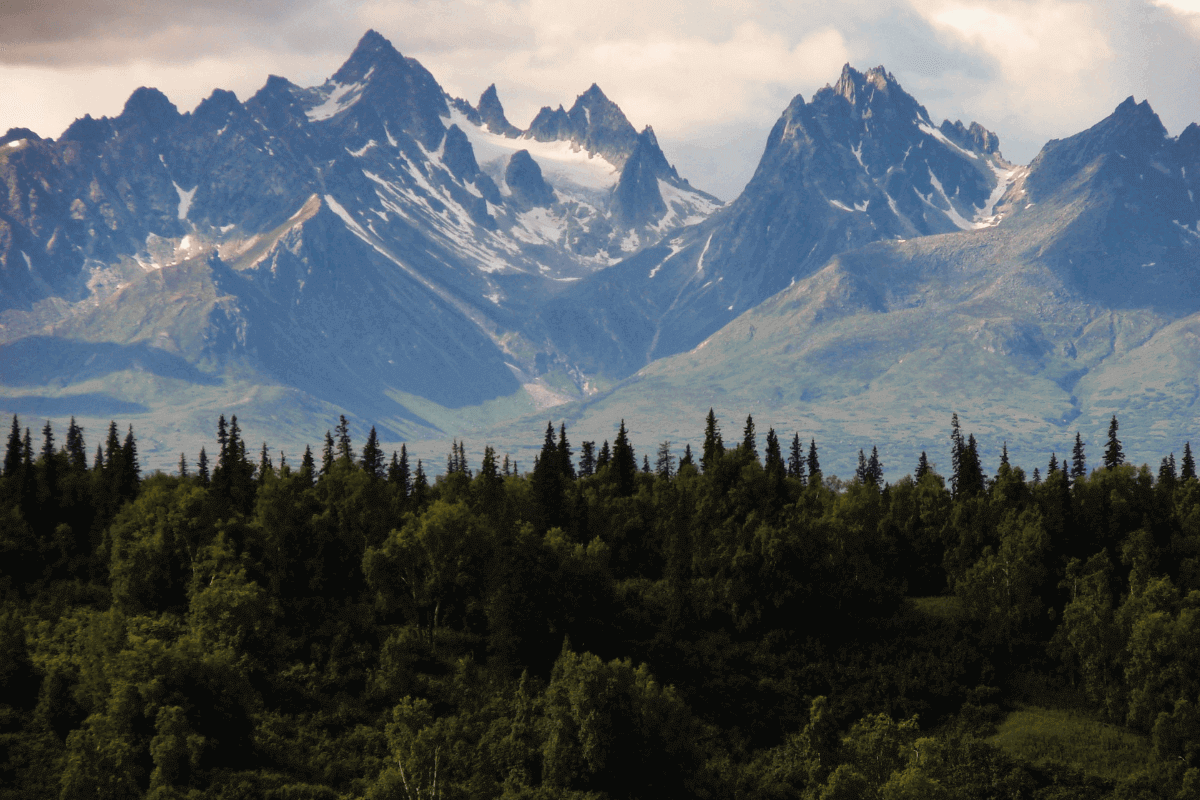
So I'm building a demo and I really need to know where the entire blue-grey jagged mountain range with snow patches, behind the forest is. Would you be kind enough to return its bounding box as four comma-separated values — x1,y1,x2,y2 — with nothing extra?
0,31,1200,476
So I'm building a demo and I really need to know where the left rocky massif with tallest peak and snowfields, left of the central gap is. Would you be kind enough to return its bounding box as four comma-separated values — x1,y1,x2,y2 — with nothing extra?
0,31,719,450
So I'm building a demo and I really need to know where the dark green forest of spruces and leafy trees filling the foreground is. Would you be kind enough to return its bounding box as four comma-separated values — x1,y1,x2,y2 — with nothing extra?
0,413,1200,800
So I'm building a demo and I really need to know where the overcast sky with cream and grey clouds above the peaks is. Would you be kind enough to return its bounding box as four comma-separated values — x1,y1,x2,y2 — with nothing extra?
0,0,1200,199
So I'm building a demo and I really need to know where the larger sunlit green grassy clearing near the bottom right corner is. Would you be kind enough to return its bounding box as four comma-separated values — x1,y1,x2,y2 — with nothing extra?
989,705,1151,781
